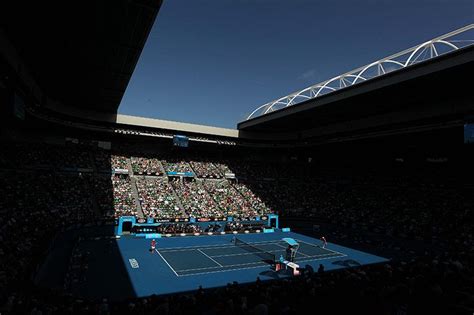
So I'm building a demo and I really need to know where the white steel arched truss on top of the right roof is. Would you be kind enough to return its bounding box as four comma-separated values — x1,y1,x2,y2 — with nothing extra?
246,24,474,120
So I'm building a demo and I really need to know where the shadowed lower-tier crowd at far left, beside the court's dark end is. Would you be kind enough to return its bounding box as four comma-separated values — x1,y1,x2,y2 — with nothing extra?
0,171,96,308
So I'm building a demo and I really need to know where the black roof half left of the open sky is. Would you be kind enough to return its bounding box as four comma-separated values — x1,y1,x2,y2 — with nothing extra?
0,0,162,113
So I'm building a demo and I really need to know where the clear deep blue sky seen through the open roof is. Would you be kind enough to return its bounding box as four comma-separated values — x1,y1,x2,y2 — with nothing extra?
119,0,474,128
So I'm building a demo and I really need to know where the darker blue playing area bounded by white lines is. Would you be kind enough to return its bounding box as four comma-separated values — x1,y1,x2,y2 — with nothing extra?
156,239,346,277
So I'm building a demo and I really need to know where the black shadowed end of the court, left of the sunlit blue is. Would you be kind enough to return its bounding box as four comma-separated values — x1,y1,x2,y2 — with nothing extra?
35,226,137,300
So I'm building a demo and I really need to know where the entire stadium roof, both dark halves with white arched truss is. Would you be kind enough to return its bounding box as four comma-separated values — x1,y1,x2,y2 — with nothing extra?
0,6,474,141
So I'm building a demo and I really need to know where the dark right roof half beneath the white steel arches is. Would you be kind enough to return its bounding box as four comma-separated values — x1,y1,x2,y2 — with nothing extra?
238,38,474,138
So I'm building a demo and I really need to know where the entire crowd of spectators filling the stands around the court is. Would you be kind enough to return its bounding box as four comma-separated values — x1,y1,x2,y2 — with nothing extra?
0,142,474,314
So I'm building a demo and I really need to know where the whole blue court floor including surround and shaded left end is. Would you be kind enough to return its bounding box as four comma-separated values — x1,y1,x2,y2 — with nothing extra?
69,230,387,298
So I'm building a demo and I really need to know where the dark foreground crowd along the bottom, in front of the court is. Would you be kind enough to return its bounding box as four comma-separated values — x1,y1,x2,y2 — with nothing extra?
3,253,473,315
